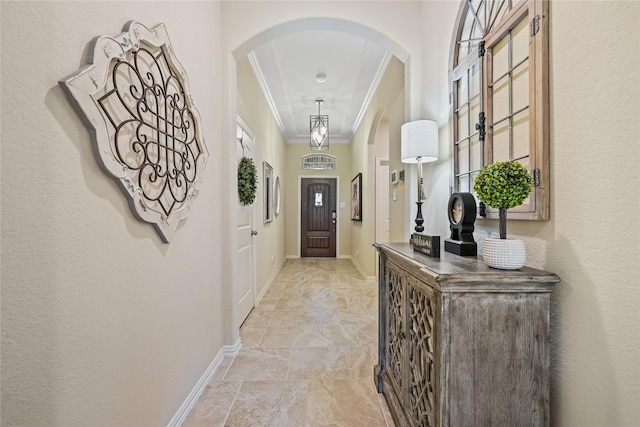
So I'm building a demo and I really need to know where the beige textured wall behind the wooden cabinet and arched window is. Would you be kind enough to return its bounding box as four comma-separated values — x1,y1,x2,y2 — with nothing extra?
422,1,640,427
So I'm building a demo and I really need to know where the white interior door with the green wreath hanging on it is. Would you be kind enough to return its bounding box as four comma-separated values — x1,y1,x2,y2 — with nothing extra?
234,124,256,325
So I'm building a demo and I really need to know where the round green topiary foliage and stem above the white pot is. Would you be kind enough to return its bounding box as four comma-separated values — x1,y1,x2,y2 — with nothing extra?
473,160,533,239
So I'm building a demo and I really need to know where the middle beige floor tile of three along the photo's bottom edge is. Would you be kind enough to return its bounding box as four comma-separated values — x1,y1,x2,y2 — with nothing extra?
225,380,308,427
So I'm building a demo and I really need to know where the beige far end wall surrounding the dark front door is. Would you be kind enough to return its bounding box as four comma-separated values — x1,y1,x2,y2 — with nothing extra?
283,141,354,258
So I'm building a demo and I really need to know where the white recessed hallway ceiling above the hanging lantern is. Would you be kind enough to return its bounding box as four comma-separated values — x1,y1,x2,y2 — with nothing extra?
249,30,390,144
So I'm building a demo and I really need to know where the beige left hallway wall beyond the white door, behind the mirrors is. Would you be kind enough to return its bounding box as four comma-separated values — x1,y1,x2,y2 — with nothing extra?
237,57,290,298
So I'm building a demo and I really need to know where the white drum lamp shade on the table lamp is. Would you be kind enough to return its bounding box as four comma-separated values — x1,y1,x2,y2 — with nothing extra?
400,120,438,163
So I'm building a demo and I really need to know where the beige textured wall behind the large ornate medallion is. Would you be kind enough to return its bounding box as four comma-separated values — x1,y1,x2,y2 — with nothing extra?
0,1,223,426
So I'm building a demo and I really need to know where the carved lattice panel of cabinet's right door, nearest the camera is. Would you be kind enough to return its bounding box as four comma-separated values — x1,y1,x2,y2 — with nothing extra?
408,283,436,427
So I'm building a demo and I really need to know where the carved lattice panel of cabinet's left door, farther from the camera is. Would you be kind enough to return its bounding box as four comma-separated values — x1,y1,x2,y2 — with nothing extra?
387,264,405,392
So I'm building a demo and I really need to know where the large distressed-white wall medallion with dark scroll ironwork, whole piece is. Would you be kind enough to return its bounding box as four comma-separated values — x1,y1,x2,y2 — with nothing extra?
60,21,209,243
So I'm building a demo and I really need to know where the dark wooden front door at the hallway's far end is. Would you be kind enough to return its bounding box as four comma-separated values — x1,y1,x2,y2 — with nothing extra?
300,178,338,257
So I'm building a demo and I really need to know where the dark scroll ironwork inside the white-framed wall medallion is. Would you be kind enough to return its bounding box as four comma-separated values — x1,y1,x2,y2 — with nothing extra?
98,49,202,216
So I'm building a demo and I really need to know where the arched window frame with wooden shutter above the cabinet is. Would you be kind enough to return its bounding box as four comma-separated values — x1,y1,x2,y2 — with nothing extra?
449,0,550,220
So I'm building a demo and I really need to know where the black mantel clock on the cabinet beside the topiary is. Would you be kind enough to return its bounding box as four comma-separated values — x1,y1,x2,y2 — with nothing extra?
444,193,478,256
